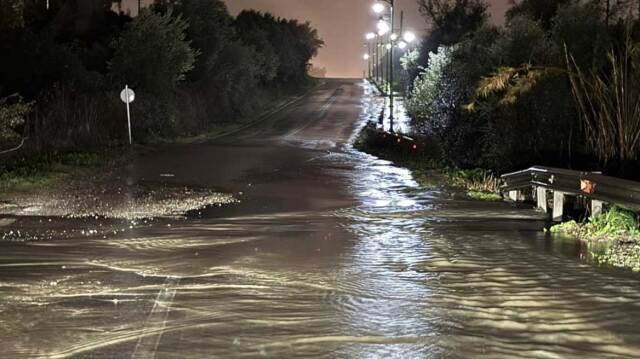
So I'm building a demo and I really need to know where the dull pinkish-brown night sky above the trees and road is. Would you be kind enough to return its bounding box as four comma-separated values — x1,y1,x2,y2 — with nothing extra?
125,0,509,77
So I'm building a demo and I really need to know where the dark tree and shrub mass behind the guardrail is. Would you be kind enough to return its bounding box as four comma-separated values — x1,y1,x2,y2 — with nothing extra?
408,0,640,177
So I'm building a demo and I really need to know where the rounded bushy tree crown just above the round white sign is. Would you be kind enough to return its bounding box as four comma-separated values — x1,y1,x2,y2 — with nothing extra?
110,9,198,95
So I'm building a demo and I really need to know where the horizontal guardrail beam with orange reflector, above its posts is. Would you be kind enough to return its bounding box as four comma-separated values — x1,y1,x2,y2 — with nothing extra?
502,166,640,210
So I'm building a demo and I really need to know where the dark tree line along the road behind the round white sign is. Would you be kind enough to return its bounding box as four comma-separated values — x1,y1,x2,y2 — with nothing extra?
0,0,323,150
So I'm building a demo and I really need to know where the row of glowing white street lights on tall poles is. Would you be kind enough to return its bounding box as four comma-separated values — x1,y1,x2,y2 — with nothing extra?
363,0,416,132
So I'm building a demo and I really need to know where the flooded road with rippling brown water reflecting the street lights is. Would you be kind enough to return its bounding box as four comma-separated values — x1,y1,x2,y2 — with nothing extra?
0,81,640,358
